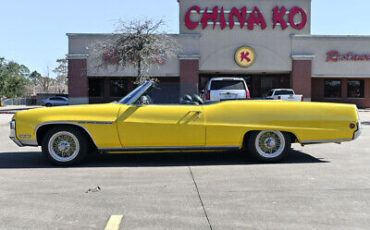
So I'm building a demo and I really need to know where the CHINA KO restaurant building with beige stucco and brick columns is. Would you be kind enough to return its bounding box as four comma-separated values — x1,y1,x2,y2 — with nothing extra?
67,0,370,108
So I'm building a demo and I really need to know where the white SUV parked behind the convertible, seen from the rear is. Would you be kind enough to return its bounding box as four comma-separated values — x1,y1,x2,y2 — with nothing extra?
205,77,250,102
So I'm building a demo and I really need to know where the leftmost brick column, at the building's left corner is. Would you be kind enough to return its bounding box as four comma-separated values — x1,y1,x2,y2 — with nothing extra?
68,58,89,105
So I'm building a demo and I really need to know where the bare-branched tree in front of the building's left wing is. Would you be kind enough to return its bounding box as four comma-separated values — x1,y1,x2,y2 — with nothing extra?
93,20,179,84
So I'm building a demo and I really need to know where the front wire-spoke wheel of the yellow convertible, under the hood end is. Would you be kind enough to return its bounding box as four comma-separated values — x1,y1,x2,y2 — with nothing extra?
42,127,89,166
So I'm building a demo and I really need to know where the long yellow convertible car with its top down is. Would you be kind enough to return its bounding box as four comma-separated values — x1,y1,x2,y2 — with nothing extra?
10,81,361,165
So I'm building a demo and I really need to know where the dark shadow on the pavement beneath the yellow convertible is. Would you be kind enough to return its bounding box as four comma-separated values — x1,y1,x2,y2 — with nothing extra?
0,150,328,169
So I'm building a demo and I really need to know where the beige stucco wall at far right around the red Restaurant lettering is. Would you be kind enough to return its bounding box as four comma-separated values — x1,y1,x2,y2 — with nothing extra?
292,35,370,78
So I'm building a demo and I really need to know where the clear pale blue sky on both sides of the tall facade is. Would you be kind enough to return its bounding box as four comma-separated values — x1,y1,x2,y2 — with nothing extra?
0,0,370,77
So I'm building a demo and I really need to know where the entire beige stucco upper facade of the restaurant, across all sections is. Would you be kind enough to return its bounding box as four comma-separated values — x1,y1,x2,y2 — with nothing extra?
68,0,370,78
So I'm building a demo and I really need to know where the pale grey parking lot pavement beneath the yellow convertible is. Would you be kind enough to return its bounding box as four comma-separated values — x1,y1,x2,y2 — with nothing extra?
0,110,370,230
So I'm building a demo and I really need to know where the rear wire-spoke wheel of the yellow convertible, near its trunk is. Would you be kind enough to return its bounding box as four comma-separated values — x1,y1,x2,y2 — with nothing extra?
247,130,291,162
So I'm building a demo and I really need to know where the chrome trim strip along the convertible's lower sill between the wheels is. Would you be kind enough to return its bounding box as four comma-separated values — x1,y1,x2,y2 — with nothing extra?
99,146,239,152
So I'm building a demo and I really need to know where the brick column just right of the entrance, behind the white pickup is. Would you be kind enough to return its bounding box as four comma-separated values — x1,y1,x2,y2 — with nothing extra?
290,55,313,101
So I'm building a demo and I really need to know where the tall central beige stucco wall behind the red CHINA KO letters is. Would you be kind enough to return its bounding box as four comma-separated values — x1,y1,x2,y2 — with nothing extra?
179,0,311,73
